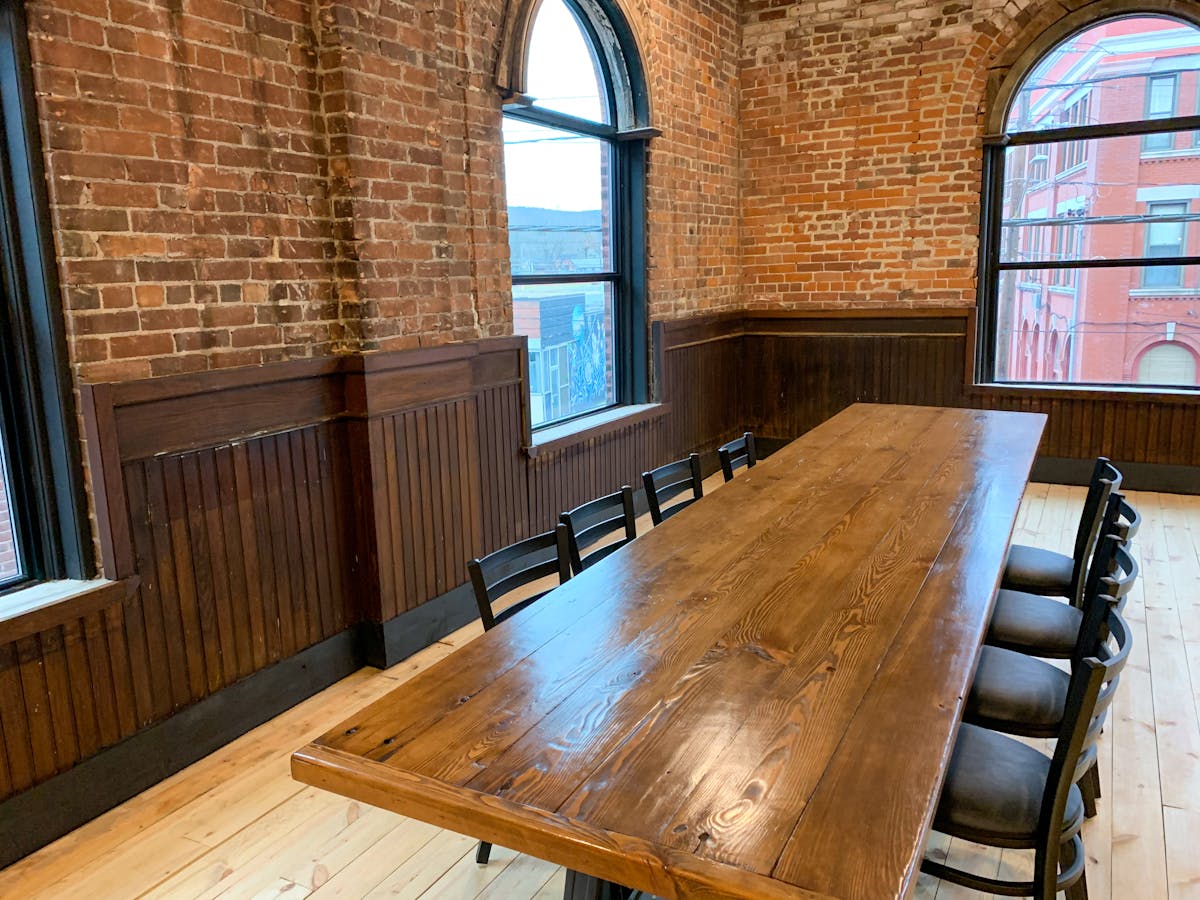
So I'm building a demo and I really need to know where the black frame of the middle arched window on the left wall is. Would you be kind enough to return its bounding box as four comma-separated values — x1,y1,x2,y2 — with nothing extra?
503,0,659,433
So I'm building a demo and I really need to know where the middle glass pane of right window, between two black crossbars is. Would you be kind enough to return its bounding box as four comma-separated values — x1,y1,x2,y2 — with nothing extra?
1000,134,1200,263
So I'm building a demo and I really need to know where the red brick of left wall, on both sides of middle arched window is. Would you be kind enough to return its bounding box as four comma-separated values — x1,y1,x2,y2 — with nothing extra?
28,0,739,380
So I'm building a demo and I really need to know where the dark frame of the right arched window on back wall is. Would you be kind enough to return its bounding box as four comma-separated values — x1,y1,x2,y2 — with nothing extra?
974,0,1200,391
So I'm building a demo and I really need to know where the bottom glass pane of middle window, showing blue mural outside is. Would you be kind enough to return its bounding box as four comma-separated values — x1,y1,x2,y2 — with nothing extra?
512,282,617,427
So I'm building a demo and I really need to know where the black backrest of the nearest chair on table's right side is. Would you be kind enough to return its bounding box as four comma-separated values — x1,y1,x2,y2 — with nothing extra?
1034,601,1130,884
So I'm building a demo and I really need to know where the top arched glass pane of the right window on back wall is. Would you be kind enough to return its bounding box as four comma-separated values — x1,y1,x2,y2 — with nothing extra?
1006,16,1200,133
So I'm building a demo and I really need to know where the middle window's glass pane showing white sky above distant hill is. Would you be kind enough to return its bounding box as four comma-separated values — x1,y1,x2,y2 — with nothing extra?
504,116,612,275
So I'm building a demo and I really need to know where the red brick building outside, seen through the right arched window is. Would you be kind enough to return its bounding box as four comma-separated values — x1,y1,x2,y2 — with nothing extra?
1000,18,1200,384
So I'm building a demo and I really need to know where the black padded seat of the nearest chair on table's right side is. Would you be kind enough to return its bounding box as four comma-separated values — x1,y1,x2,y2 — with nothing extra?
934,722,1084,850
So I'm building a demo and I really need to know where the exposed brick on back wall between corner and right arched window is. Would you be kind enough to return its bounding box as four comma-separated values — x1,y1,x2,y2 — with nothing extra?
740,0,1036,308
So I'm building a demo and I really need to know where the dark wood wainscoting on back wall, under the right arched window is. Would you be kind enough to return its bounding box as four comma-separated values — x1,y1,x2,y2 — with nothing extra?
742,310,1200,480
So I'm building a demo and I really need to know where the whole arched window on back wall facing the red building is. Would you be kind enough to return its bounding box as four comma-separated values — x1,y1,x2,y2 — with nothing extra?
977,11,1200,386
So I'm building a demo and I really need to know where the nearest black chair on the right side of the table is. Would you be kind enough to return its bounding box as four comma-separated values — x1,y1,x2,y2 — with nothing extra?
920,604,1130,900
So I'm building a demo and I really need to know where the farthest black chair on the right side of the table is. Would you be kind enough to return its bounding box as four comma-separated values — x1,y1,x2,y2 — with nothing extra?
1000,456,1121,606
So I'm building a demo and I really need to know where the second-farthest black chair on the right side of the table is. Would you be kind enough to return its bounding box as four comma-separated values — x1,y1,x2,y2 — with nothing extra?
984,492,1141,659
